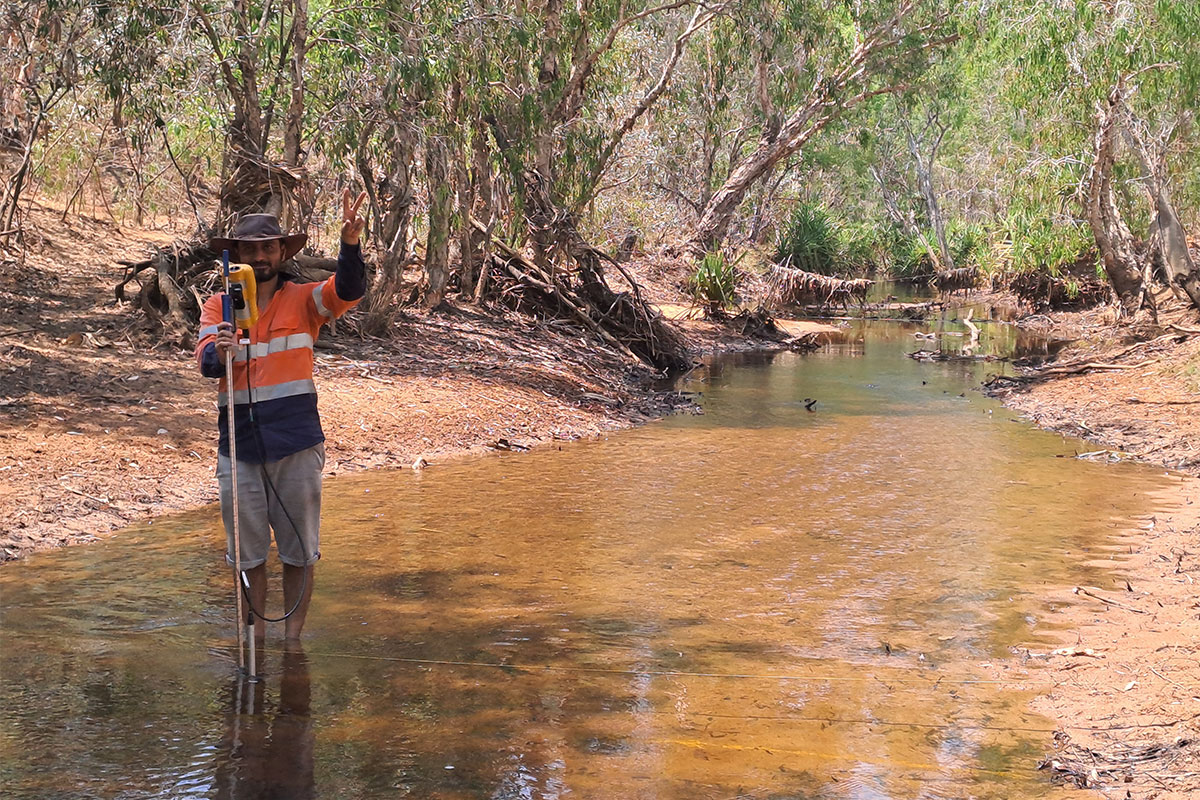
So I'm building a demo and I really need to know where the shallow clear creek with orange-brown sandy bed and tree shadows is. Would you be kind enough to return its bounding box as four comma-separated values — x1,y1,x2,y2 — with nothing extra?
0,323,1180,800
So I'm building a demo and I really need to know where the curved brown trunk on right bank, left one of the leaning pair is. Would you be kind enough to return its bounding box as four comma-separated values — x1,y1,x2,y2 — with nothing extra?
1087,84,1142,314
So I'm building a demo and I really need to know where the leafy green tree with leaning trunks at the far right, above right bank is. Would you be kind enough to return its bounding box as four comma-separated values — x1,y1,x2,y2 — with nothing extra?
996,0,1200,313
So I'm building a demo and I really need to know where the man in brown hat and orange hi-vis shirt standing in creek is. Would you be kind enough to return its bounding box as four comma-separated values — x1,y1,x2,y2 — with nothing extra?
196,190,366,640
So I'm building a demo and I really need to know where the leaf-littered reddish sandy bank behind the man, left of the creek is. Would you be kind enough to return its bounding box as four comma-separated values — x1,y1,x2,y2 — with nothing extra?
0,207,836,561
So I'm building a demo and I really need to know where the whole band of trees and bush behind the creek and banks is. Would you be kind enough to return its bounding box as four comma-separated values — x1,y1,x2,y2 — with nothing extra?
0,0,1200,366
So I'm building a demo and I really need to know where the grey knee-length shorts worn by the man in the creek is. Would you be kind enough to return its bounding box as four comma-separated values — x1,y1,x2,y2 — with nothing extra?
217,443,325,570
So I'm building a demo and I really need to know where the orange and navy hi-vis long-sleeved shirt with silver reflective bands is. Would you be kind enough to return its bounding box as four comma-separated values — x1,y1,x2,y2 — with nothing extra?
196,243,366,463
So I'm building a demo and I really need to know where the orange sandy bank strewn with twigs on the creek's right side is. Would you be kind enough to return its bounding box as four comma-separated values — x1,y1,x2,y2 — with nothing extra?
992,297,1200,800
